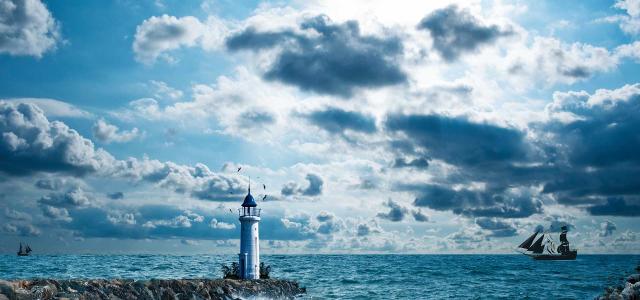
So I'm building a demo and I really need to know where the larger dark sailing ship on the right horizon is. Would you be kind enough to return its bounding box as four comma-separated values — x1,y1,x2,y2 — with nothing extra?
517,226,578,260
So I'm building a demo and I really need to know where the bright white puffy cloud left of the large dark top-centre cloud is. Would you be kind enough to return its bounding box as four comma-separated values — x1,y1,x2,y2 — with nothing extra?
133,14,227,64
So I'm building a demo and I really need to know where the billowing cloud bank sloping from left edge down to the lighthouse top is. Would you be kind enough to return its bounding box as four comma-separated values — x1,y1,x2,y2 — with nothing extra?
0,101,248,201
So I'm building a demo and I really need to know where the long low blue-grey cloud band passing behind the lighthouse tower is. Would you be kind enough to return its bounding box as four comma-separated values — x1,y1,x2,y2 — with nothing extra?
60,204,320,241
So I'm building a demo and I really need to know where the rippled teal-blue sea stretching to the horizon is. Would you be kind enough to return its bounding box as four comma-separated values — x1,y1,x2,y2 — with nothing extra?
0,254,640,299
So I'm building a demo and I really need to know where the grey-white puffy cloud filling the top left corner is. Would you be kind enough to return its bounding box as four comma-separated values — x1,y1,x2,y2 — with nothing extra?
0,0,60,58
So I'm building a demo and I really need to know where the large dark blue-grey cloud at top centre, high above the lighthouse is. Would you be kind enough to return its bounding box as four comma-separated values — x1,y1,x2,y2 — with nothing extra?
226,15,406,97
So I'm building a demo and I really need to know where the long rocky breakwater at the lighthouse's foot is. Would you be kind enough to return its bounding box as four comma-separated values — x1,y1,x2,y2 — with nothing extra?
0,279,306,300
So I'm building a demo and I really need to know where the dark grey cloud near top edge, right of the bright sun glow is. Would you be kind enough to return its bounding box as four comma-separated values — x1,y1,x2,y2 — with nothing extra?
418,5,512,61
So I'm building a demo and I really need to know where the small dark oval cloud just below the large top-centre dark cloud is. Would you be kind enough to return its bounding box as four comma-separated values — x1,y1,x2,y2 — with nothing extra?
304,107,376,134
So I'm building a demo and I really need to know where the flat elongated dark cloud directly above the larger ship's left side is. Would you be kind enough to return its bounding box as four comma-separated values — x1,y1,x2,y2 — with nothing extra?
404,184,542,218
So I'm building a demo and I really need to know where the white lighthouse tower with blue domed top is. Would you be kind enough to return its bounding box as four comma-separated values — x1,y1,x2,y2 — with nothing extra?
238,183,260,279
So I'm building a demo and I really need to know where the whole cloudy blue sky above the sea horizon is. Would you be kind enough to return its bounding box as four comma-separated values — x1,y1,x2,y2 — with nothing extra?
0,0,640,254
